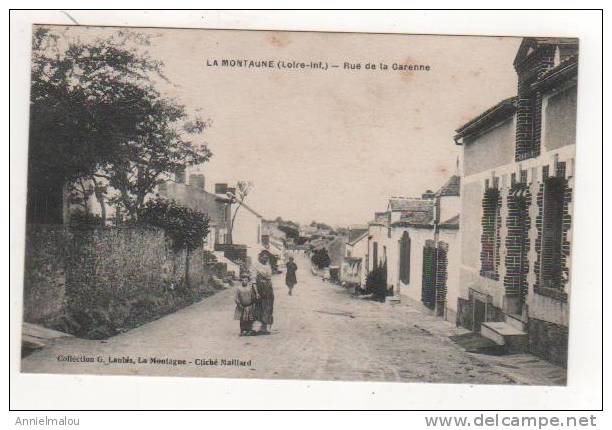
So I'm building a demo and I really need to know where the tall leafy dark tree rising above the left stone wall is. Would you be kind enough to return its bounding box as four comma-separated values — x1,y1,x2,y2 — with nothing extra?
28,27,212,225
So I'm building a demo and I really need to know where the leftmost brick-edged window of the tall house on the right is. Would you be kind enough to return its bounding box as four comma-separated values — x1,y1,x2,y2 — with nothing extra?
480,188,501,280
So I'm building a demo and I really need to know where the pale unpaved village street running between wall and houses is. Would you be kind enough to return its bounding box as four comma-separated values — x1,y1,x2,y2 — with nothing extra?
22,257,565,385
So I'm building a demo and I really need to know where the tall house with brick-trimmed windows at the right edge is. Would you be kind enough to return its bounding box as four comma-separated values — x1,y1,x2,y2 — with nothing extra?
455,38,578,364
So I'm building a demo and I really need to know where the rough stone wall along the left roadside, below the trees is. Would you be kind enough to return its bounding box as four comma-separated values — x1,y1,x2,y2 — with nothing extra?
24,225,226,338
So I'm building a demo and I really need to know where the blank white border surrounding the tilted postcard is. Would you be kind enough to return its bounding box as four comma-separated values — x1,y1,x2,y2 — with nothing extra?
3,7,602,410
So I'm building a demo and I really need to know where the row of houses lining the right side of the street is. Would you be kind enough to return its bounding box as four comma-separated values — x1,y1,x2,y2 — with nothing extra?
342,38,578,365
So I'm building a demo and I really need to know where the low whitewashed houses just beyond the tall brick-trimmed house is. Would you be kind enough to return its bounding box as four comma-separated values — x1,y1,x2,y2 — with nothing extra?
365,175,461,320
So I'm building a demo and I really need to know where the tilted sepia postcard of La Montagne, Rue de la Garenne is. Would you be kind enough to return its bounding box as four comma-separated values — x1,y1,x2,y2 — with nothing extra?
21,25,579,385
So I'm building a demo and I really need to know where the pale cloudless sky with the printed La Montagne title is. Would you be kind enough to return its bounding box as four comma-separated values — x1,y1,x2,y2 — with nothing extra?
45,27,521,226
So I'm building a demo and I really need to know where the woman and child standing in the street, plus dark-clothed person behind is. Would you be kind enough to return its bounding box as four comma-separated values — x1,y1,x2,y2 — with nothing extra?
234,251,297,336
